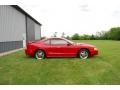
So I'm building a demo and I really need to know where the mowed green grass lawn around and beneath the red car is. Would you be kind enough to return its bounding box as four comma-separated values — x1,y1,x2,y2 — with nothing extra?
0,40,120,85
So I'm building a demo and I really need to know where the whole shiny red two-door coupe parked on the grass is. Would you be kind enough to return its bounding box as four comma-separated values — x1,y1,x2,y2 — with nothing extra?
25,38,98,59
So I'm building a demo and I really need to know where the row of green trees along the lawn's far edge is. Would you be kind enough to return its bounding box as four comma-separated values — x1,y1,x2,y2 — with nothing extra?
70,27,120,40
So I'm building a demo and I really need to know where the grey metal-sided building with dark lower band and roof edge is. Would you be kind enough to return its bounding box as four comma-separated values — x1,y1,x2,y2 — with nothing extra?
0,5,41,53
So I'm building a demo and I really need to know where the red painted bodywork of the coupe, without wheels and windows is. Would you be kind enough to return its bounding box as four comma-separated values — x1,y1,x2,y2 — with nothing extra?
25,39,98,57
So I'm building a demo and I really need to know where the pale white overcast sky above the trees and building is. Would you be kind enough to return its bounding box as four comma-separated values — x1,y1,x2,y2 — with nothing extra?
1,0,120,37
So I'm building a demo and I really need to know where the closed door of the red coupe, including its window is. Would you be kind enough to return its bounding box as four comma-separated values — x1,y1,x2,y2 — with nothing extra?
50,39,75,57
